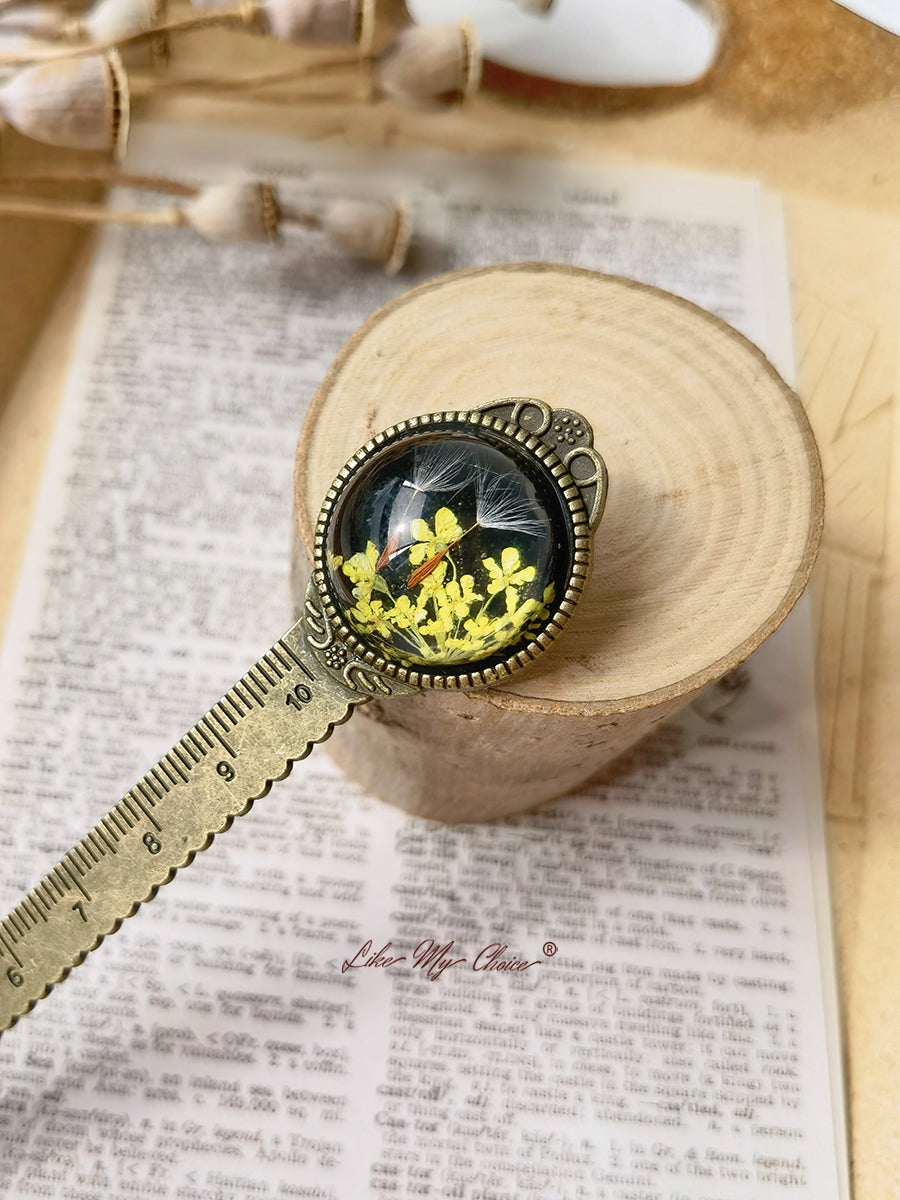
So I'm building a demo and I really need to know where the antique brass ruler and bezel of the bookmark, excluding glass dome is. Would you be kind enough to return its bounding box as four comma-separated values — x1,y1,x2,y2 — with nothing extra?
0,398,606,1031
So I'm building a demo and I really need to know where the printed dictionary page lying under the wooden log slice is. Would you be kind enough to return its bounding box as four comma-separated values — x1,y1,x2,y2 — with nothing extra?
0,124,847,1200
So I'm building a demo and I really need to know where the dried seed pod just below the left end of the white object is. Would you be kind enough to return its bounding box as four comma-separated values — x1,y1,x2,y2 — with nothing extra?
373,20,481,108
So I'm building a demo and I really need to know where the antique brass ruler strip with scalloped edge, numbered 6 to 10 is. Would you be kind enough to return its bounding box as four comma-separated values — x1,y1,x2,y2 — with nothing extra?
0,620,368,1031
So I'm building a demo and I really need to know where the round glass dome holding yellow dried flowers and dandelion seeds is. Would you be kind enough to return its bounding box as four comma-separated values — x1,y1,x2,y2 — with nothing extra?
325,426,574,672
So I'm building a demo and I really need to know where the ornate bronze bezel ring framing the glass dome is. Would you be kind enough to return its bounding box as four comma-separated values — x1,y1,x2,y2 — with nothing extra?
307,397,607,694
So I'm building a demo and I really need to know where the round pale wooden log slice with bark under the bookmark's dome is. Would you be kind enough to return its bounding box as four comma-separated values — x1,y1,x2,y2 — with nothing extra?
294,264,823,821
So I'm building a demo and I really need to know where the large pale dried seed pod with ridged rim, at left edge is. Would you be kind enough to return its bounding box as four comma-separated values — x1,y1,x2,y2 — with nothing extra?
0,52,130,157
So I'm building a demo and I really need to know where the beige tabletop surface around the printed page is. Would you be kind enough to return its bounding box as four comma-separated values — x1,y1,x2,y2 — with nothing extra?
0,0,900,1200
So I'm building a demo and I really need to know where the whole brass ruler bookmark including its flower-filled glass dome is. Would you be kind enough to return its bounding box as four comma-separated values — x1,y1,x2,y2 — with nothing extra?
0,397,607,1031
